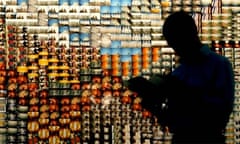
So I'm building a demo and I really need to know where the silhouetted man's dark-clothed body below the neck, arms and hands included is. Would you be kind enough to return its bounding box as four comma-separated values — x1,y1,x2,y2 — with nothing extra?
129,47,234,143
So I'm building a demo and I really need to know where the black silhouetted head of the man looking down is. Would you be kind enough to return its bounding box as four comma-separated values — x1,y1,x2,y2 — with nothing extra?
163,11,201,57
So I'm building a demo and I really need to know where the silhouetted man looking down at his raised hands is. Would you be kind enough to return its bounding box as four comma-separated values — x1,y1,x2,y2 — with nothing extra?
128,11,234,144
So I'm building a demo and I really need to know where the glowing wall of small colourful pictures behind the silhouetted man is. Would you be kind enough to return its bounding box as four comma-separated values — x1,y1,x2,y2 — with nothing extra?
0,0,240,144
